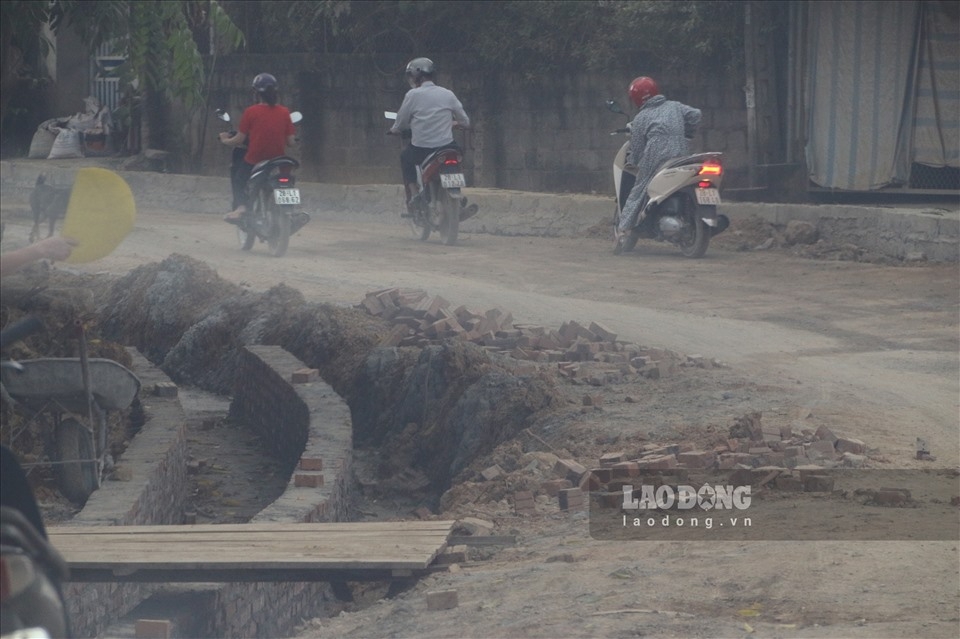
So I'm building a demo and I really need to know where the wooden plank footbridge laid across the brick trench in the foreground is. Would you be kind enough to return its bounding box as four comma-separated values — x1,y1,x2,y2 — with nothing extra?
49,520,455,582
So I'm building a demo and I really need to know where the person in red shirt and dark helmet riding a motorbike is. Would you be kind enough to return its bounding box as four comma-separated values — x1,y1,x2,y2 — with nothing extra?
220,73,296,224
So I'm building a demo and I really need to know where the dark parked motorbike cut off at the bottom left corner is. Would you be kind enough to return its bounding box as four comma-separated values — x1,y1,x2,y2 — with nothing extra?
0,321,72,639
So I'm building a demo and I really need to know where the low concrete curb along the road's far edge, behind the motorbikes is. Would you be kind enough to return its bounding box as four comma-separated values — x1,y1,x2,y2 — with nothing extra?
0,158,960,262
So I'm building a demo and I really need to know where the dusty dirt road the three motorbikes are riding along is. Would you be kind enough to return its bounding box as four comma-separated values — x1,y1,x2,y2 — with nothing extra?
16,210,960,465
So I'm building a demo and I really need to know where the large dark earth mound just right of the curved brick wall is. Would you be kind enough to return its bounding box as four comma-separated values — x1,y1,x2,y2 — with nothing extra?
351,341,565,488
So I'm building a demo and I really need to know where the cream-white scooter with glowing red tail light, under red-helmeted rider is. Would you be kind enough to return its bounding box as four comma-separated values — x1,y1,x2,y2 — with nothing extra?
607,100,730,258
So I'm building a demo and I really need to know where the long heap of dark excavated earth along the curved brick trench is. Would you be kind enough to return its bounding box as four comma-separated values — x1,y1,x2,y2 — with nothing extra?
94,255,564,494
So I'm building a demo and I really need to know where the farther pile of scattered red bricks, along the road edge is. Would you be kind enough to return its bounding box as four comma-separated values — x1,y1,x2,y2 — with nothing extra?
358,288,721,386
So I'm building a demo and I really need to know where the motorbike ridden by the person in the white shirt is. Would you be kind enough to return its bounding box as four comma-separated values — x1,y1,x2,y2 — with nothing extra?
383,111,477,246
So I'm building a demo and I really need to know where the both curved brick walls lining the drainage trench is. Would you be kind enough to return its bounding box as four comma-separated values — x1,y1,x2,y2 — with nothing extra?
66,346,353,637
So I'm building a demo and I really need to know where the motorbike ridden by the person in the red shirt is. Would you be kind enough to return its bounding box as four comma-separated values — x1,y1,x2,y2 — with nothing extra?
217,109,310,257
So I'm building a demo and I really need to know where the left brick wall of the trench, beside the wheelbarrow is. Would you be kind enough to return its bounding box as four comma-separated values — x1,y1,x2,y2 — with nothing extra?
64,349,189,637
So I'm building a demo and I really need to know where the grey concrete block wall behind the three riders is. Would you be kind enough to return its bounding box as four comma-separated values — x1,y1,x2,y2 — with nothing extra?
201,54,748,193
